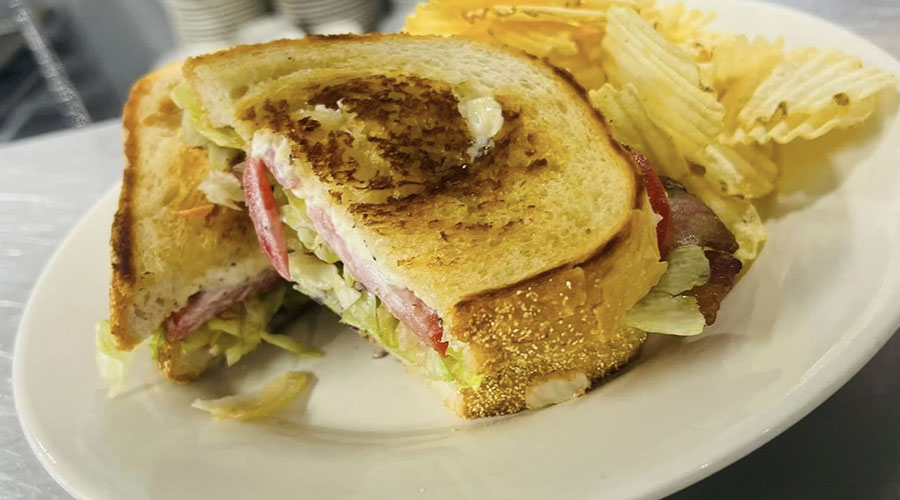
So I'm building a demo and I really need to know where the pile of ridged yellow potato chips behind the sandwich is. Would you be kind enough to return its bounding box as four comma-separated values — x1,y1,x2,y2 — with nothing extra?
406,0,898,264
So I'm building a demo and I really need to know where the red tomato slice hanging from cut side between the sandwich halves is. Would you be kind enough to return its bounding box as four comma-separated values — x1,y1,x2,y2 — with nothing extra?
243,158,291,280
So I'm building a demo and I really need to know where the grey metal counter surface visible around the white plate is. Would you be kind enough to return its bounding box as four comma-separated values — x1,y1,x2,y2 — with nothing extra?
0,0,900,500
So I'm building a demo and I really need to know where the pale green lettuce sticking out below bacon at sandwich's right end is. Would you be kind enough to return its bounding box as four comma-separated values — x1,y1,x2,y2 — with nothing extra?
625,245,709,336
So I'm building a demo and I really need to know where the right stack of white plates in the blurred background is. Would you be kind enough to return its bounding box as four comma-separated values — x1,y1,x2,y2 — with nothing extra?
275,0,381,33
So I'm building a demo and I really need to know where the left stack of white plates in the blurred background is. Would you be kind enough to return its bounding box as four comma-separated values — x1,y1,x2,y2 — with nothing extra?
164,0,266,44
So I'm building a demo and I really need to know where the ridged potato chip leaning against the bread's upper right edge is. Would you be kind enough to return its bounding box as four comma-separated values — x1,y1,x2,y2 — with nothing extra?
589,83,688,179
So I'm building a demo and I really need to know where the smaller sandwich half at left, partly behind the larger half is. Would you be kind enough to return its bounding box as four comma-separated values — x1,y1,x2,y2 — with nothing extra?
97,64,306,390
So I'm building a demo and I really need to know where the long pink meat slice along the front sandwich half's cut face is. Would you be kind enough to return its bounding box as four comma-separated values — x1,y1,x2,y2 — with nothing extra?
306,204,448,356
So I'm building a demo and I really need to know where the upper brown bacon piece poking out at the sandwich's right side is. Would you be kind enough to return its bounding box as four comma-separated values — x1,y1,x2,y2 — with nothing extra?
661,177,738,254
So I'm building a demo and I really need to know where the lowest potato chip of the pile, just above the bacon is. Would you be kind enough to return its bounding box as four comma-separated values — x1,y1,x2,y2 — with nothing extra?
679,175,769,265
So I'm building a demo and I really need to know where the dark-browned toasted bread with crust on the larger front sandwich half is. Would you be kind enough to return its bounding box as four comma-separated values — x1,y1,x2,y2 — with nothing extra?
184,35,665,417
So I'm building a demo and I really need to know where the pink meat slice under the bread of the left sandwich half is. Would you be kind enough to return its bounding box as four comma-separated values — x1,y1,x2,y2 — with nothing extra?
164,269,281,342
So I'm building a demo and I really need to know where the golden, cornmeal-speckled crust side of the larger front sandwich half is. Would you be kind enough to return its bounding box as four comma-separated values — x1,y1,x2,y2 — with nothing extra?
450,197,666,418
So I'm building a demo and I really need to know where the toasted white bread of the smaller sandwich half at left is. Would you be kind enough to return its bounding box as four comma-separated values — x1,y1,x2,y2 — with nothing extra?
110,65,271,381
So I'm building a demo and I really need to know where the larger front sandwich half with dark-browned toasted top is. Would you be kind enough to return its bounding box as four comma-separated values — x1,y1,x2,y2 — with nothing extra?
171,35,740,418
